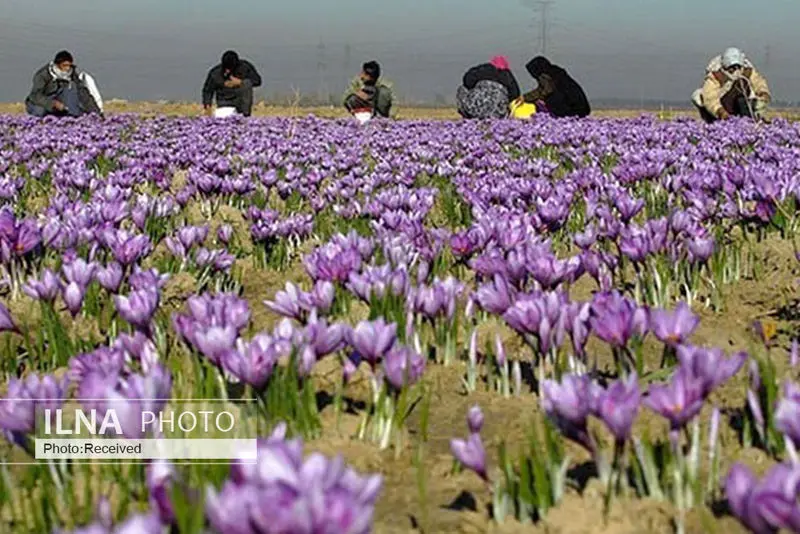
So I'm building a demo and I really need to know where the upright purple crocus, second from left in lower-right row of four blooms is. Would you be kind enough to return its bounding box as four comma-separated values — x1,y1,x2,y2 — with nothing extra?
592,373,642,444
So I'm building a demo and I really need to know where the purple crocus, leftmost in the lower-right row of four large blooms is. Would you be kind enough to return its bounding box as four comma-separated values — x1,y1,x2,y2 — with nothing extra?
542,375,594,452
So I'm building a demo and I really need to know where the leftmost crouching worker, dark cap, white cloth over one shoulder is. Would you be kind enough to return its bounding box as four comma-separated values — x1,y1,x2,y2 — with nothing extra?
25,50,103,117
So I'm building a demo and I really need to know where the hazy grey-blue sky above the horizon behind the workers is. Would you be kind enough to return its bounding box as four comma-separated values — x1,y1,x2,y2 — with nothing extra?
0,0,800,102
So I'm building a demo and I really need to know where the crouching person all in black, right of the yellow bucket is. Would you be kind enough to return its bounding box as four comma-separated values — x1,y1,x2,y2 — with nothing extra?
523,56,591,117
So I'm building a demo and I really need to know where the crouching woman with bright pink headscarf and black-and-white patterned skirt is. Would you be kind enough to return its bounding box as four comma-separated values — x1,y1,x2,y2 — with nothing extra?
456,56,520,119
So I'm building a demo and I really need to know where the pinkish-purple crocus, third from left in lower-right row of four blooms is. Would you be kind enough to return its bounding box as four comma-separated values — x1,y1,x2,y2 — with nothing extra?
644,367,705,430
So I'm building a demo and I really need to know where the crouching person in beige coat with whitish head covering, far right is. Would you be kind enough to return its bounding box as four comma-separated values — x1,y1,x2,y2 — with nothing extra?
692,48,772,123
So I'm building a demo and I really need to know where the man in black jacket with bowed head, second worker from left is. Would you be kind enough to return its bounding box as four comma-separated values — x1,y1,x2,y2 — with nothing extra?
203,50,261,117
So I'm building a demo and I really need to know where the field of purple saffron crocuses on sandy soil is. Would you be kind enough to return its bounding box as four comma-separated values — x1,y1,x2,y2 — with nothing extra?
0,115,800,534
